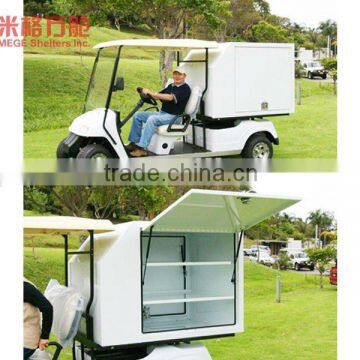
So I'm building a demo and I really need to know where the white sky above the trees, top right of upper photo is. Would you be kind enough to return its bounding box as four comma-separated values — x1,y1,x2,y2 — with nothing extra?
267,0,338,27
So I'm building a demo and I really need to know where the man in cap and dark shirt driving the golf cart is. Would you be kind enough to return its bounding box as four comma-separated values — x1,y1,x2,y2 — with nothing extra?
126,68,191,157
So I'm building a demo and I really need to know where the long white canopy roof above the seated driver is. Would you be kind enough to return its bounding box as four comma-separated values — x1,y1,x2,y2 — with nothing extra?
94,39,218,50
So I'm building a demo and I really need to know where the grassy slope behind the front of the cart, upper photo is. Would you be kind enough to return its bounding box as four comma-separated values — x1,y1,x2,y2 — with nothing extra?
24,55,160,132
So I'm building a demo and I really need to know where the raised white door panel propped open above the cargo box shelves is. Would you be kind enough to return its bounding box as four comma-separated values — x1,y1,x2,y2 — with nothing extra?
143,189,300,233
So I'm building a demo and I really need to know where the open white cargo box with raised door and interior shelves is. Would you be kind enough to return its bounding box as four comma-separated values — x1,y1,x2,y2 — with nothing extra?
69,190,296,347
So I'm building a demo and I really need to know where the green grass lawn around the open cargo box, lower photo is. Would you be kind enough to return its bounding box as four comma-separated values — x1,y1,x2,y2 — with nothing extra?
24,248,337,360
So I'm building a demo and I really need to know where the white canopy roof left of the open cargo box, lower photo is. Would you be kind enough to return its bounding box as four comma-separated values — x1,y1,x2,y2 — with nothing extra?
23,216,115,235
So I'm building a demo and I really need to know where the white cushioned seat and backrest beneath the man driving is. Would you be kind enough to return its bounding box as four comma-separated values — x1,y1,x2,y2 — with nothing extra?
156,86,202,137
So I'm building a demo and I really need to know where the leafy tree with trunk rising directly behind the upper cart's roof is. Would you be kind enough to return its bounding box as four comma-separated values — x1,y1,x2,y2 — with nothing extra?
65,0,229,85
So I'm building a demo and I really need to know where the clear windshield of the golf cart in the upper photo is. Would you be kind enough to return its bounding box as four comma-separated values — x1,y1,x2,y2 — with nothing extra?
84,48,118,112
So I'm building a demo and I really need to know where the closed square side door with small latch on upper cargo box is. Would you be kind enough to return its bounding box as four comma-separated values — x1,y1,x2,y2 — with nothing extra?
235,45,294,116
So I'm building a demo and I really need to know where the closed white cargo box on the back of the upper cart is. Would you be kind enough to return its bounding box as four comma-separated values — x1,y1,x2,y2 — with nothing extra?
181,43,295,119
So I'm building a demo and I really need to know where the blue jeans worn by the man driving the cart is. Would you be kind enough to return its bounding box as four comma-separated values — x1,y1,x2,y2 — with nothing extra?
129,111,181,149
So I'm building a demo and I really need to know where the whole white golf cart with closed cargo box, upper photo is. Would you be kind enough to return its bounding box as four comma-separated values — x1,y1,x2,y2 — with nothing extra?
57,39,294,159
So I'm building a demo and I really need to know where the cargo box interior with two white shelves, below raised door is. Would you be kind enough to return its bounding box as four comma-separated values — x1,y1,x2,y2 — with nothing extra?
141,233,236,333
